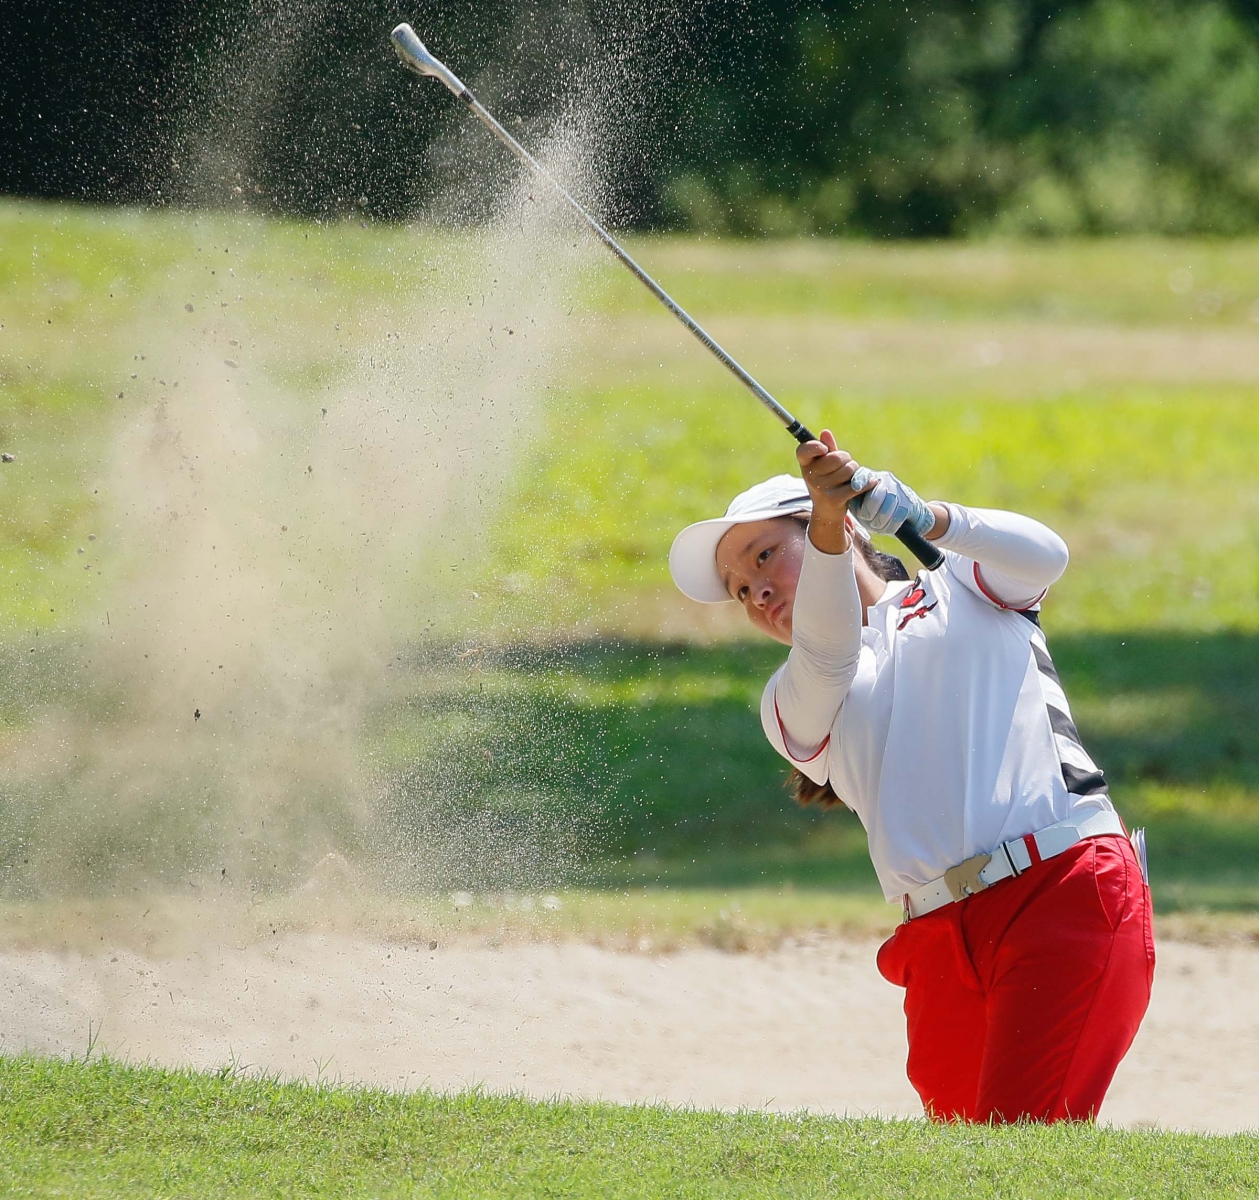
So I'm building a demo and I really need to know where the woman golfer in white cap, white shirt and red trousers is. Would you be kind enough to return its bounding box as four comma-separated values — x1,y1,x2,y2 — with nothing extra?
670,431,1155,1122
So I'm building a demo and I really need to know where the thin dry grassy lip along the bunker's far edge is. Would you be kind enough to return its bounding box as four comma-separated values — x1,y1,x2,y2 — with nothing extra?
0,876,901,957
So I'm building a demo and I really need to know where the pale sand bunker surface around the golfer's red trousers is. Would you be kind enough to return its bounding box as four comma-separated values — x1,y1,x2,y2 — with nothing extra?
0,934,1259,1132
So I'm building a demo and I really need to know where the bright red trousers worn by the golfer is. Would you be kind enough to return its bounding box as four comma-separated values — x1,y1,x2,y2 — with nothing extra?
879,836,1155,1122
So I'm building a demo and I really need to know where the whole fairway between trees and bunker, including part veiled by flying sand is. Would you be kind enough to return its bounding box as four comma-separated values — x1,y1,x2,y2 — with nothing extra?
0,201,1259,912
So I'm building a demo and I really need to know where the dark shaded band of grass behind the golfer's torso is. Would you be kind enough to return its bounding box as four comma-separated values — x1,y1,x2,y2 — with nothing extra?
393,632,1259,908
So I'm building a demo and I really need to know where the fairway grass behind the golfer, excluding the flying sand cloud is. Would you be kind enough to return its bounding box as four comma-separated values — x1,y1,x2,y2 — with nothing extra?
0,201,1259,913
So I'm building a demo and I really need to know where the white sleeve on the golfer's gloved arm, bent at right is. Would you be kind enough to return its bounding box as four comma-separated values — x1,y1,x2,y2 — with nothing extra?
935,504,1069,612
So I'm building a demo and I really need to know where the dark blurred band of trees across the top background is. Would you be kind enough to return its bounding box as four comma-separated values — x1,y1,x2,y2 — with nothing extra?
7,0,1259,237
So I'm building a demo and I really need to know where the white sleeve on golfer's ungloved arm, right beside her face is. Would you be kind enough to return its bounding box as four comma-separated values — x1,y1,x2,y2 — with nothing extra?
760,538,861,783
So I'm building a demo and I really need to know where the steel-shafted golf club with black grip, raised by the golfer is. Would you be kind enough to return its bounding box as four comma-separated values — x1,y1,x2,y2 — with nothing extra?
390,21,944,570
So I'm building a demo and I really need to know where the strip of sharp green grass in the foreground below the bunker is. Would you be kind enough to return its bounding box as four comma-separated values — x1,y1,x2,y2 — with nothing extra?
0,1059,1259,1200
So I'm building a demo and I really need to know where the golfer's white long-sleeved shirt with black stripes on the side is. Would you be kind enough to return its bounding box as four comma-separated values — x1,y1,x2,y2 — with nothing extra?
760,505,1110,900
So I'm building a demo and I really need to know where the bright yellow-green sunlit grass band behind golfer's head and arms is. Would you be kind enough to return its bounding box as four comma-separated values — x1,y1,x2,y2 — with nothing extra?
491,384,1259,632
